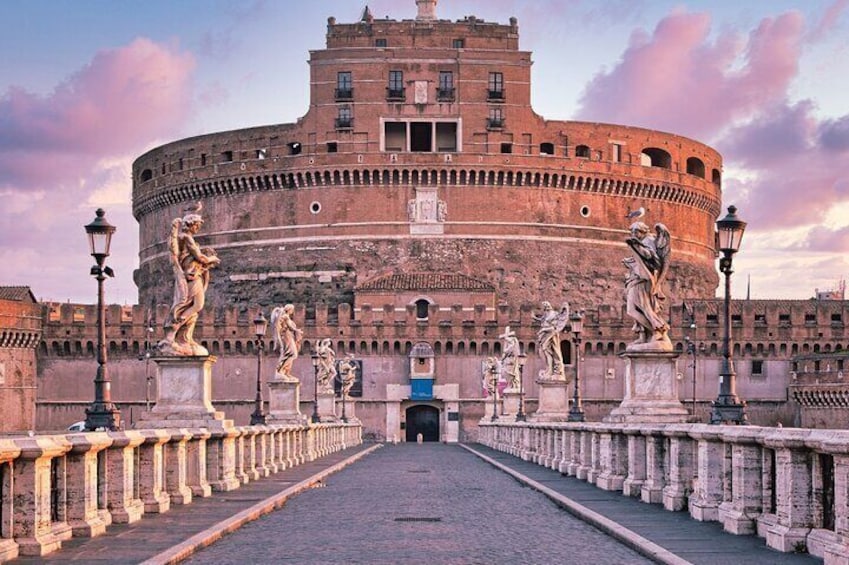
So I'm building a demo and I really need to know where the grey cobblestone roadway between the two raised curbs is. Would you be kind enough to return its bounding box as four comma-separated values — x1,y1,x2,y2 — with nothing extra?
187,444,651,565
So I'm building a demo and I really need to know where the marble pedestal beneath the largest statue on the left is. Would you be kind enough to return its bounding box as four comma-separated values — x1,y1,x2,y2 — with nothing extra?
136,355,233,430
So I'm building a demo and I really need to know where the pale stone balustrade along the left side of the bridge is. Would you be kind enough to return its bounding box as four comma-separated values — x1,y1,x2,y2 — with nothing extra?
0,423,362,562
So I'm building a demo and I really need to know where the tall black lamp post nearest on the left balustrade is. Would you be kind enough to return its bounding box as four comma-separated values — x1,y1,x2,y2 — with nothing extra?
85,208,121,430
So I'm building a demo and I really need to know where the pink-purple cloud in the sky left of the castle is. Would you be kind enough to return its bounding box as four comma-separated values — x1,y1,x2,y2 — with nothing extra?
0,39,195,189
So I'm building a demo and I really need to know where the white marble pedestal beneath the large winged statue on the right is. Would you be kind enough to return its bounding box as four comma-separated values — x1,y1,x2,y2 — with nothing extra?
604,351,689,424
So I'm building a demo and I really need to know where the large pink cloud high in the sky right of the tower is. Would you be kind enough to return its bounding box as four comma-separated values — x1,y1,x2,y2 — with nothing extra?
578,12,804,139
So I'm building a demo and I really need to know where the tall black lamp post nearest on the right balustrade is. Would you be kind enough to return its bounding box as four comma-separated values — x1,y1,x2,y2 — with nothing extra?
710,206,748,424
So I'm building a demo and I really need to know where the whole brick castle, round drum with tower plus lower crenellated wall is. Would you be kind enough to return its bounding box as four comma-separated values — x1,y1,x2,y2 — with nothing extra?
0,0,849,441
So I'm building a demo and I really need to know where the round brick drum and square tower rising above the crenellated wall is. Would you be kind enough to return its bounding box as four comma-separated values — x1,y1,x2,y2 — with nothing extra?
133,3,722,306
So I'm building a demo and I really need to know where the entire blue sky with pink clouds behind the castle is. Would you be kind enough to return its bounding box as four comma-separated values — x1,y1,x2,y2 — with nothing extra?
0,0,849,304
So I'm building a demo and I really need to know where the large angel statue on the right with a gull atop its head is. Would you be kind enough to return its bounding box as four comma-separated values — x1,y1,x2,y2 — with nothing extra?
622,222,672,351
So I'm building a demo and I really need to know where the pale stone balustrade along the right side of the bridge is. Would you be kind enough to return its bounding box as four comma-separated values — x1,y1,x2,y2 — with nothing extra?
478,422,849,564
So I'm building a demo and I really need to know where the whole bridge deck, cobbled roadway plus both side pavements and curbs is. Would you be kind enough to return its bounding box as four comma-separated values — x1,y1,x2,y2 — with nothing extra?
12,444,820,565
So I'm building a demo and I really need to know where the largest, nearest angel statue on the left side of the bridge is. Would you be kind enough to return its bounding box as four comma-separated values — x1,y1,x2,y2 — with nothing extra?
158,202,221,356
